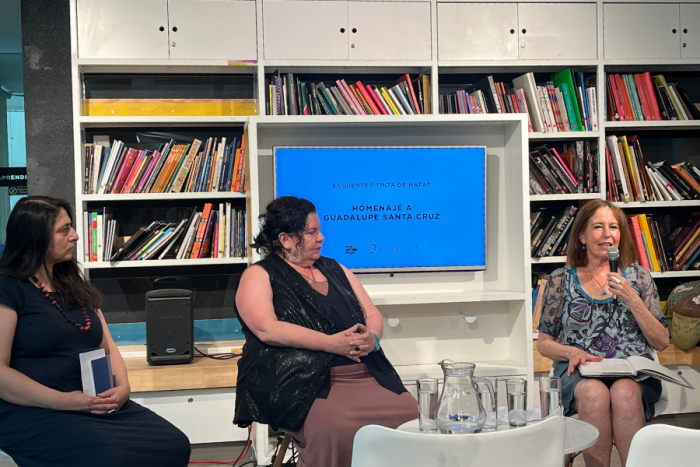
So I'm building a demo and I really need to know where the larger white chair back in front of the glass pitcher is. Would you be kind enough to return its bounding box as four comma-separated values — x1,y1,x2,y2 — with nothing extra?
352,417,566,467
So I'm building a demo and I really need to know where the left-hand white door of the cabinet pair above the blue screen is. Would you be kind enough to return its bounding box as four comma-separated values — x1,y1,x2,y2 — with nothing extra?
263,0,349,60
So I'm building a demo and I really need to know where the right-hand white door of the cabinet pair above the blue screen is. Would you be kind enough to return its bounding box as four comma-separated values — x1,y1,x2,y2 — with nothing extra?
348,2,432,61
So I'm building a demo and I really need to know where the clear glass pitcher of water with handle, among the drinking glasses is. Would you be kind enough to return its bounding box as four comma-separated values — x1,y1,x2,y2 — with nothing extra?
435,360,496,434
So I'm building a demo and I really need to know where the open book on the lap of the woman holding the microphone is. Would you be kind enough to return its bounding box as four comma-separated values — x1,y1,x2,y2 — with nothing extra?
579,356,695,389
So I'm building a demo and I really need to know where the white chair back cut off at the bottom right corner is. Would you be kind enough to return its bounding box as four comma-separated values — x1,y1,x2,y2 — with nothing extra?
627,424,700,467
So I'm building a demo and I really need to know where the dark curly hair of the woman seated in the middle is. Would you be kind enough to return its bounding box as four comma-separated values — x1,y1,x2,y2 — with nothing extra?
250,196,316,256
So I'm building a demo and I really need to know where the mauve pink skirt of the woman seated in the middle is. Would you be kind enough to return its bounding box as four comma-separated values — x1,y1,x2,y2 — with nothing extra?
290,363,418,467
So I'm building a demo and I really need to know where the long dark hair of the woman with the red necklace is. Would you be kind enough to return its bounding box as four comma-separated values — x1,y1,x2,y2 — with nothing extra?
0,196,102,310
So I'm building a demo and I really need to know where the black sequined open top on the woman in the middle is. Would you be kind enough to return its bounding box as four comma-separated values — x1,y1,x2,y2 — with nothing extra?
233,254,406,431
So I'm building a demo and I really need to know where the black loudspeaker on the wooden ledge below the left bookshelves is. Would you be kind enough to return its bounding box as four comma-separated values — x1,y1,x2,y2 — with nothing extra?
146,289,194,365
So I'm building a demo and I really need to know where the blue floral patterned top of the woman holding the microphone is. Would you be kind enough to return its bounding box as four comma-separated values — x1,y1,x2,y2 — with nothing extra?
537,265,667,358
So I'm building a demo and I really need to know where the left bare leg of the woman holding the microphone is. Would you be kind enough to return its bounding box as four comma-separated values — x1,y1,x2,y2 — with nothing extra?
572,379,613,467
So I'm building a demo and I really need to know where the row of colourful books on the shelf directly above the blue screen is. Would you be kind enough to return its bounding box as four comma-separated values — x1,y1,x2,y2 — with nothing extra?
266,72,430,115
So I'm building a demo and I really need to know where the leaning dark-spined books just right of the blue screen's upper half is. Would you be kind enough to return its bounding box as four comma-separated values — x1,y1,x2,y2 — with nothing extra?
530,140,599,195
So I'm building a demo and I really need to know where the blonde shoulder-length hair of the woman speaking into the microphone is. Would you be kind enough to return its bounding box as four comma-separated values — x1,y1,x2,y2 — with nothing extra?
566,199,637,268
